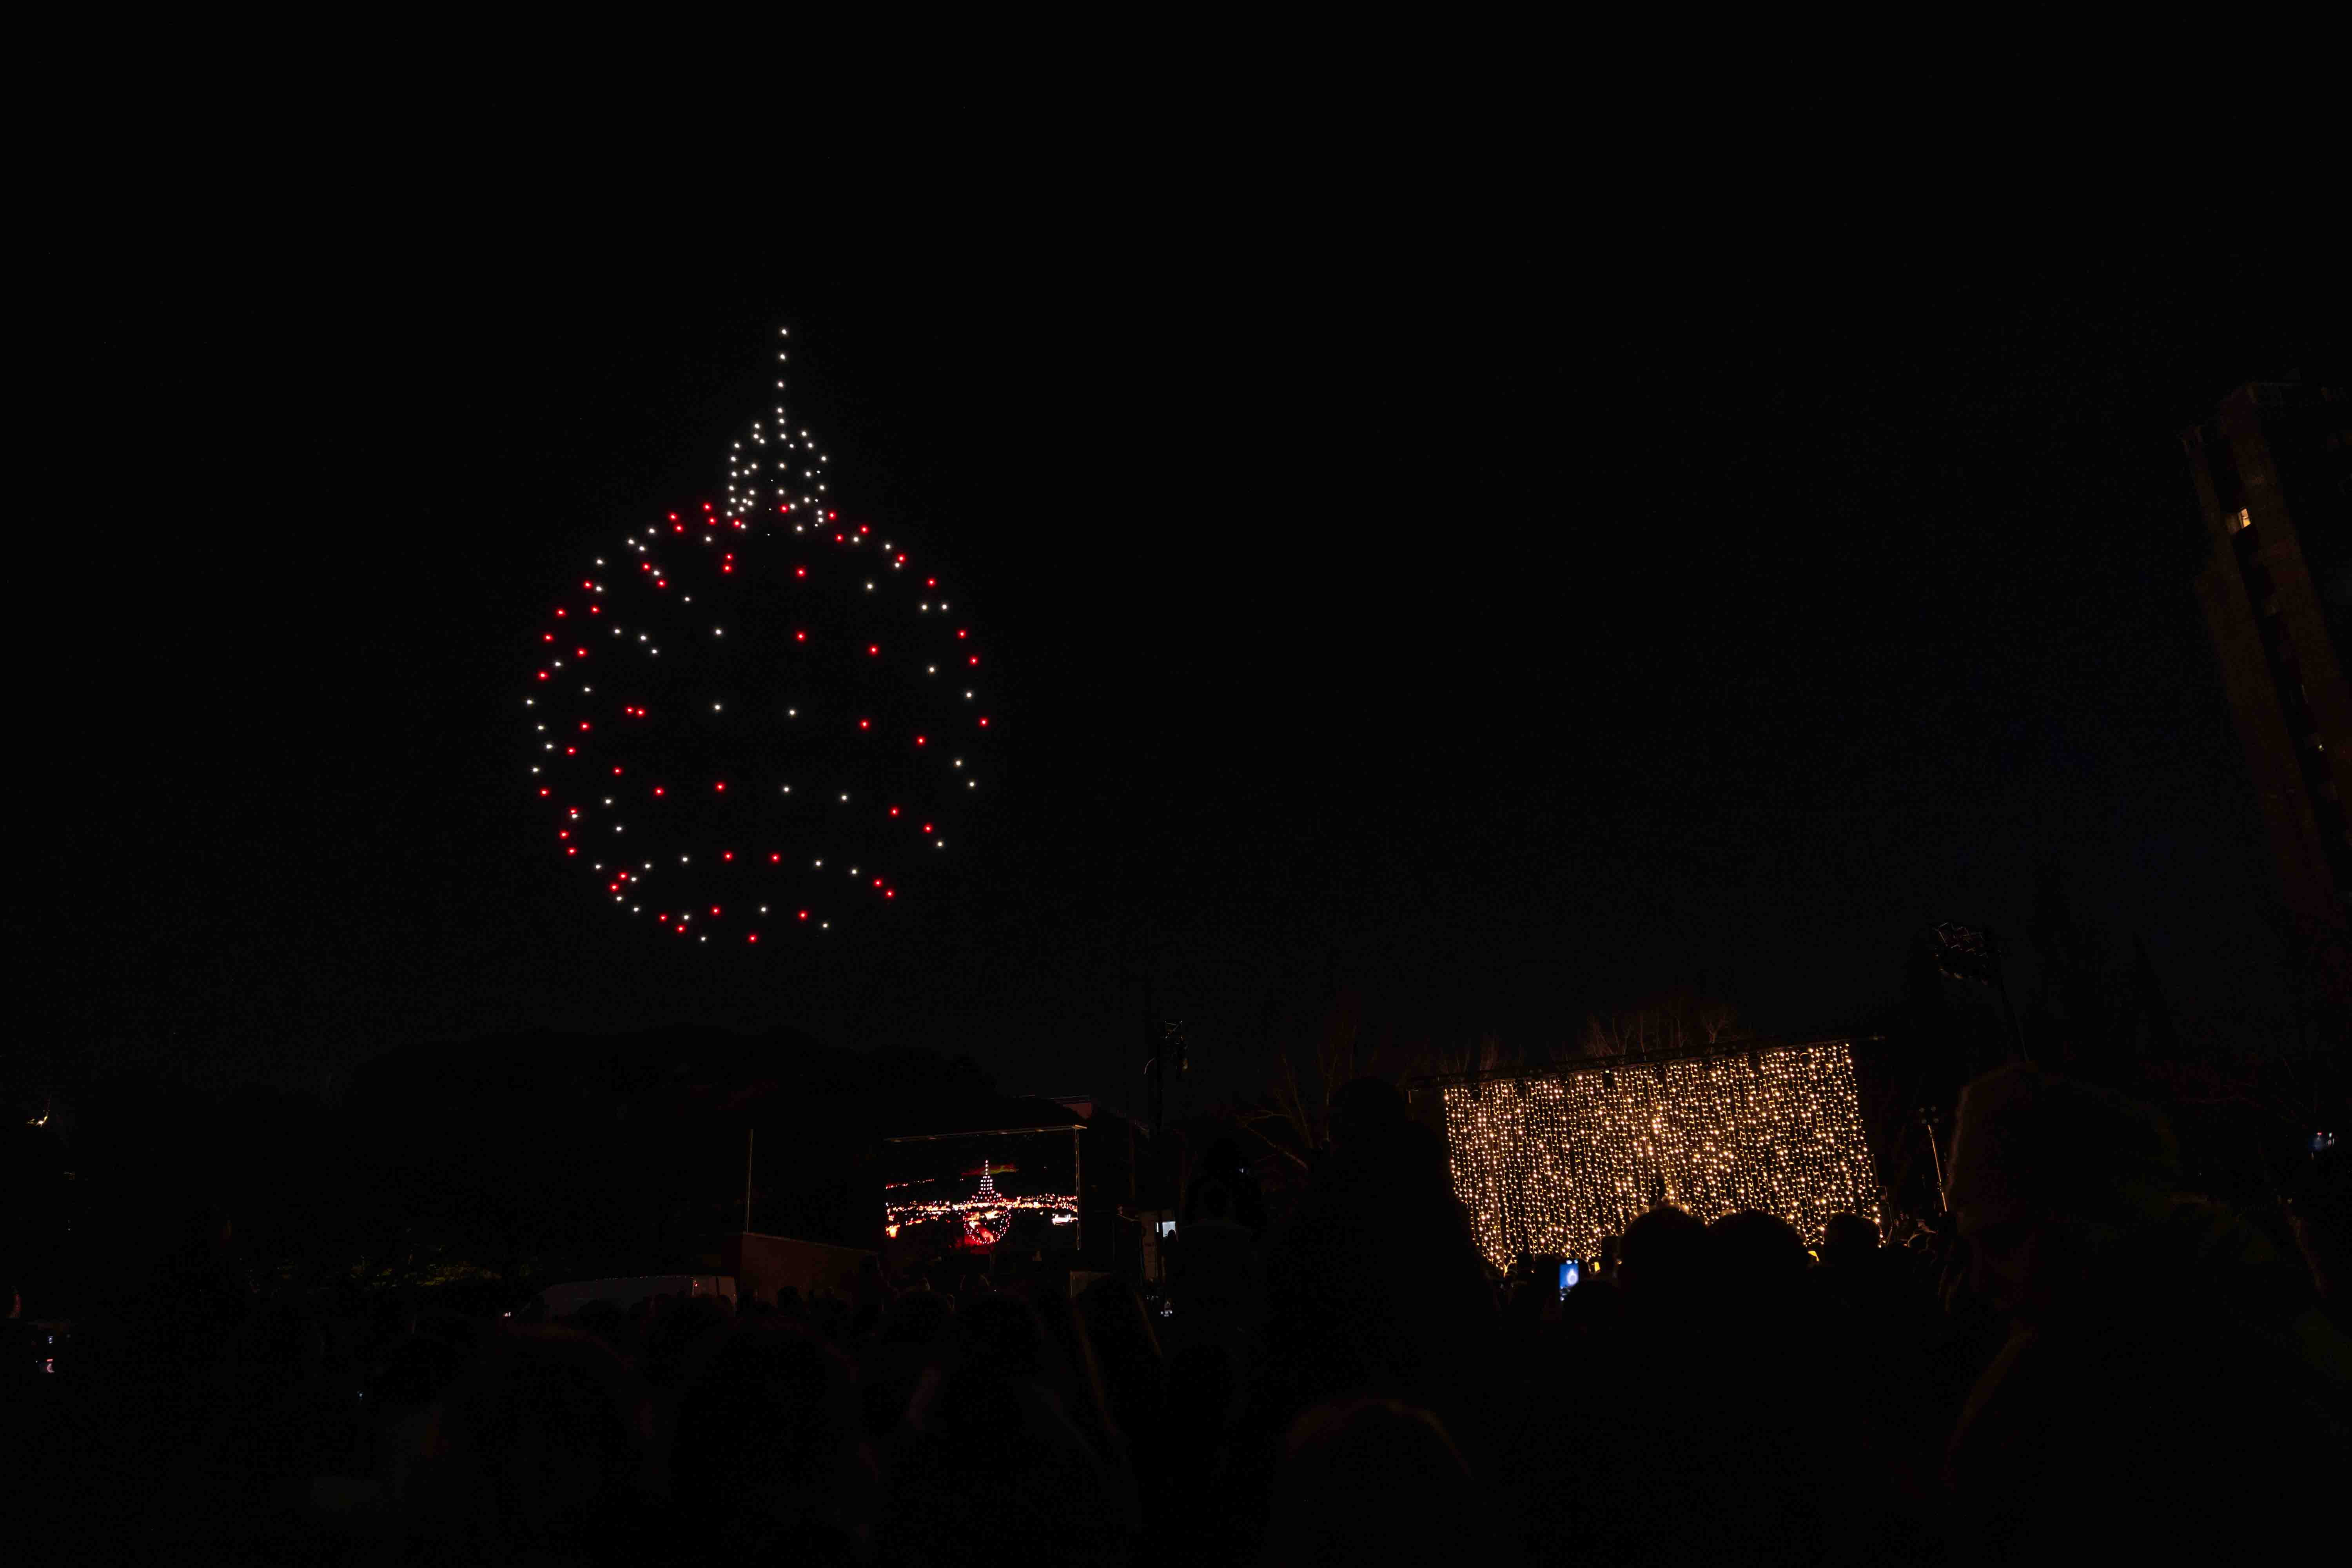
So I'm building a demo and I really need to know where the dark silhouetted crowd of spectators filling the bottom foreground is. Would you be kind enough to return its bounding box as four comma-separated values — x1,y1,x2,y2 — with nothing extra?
7,1067,2352,1566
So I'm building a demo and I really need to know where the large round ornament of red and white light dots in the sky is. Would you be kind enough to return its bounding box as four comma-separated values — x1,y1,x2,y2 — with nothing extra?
522,329,990,950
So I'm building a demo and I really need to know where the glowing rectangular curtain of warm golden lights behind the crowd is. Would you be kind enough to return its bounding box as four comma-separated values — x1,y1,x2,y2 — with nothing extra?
1444,1042,1879,1269
